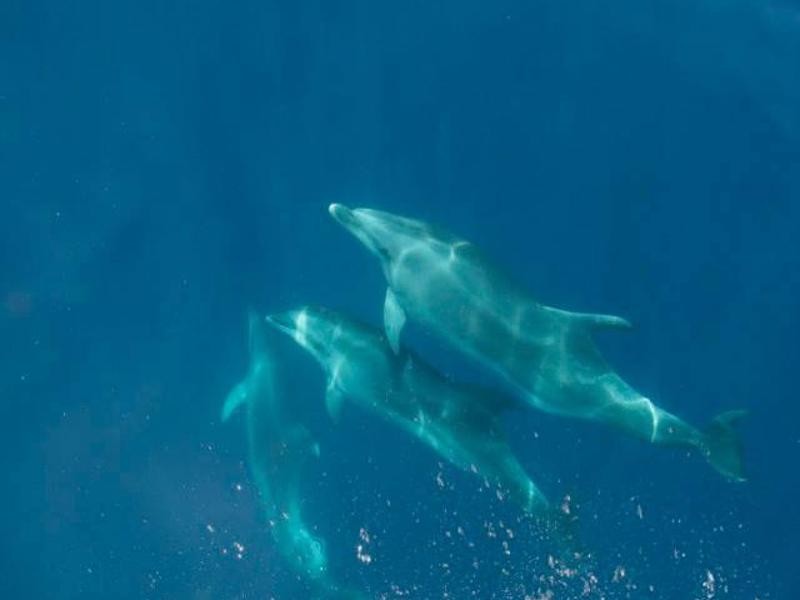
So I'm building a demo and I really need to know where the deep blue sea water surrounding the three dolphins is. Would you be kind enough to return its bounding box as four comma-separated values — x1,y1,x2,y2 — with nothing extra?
0,0,800,600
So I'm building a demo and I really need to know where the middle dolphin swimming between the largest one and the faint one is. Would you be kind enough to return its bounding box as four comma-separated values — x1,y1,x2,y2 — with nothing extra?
267,306,559,526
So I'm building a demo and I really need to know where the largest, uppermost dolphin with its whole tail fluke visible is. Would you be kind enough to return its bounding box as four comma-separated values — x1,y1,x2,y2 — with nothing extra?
329,204,744,481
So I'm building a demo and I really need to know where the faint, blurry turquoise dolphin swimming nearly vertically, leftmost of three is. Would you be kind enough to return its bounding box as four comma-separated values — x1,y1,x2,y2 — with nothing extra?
222,312,364,600
